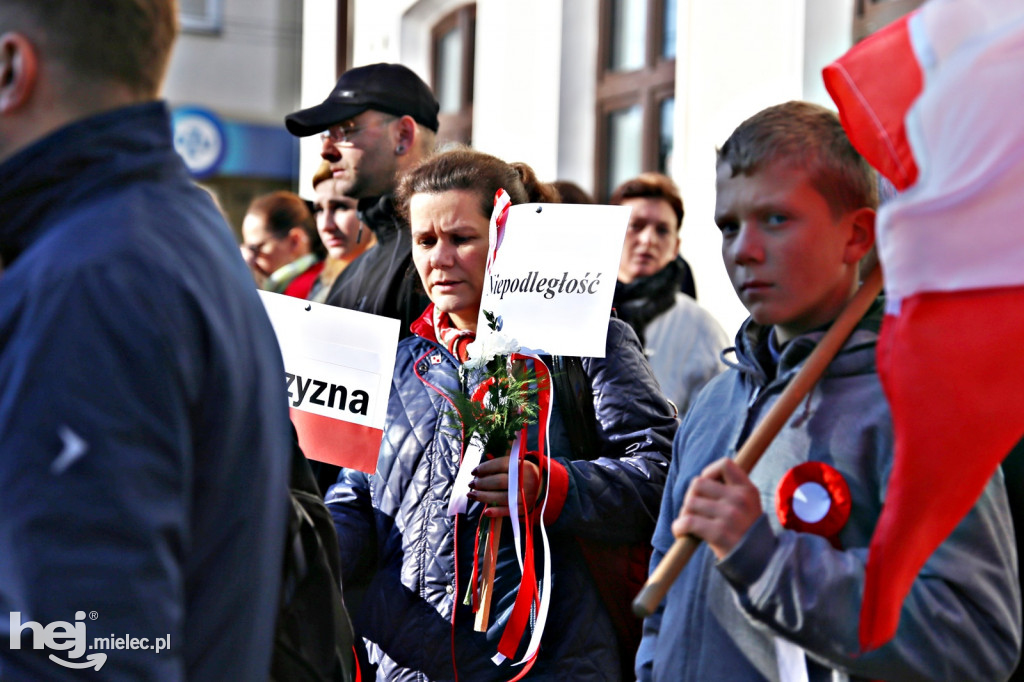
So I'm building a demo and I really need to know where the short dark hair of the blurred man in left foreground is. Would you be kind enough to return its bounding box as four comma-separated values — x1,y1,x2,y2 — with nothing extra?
0,0,178,98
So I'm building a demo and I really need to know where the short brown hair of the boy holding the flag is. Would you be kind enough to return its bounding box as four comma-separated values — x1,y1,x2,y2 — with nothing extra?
718,101,879,217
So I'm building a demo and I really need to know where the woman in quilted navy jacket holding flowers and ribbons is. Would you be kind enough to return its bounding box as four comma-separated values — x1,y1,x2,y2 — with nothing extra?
327,150,677,682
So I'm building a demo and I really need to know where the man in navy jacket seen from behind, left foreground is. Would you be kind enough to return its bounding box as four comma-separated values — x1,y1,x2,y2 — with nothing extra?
0,0,290,682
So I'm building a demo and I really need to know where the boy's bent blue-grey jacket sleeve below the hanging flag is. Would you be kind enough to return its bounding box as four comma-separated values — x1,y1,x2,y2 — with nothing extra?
720,481,1021,680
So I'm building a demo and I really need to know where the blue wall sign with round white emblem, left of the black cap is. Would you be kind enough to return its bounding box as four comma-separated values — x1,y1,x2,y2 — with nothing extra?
171,106,299,180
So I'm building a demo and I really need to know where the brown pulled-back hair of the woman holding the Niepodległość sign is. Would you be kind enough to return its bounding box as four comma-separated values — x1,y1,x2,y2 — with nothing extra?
395,147,558,222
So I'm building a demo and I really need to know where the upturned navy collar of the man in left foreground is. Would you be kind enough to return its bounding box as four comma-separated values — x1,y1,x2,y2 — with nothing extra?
0,101,173,266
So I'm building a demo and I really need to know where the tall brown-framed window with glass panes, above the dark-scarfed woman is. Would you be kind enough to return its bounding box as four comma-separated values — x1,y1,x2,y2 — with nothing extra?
594,0,677,201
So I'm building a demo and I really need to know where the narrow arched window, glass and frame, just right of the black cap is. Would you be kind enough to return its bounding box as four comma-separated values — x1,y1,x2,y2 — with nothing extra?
430,5,476,144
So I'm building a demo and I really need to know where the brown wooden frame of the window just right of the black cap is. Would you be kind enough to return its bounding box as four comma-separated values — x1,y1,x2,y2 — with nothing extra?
430,3,476,144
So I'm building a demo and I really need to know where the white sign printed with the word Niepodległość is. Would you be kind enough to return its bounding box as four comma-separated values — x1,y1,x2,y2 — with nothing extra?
480,204,630,357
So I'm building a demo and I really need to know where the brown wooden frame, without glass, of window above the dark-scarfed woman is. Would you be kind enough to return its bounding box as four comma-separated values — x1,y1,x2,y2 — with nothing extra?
594,0,676,201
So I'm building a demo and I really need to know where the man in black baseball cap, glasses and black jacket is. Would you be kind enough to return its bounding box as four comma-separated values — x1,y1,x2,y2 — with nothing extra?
285,63,438,336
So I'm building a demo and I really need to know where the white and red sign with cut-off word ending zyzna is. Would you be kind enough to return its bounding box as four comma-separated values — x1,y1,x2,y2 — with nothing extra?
260,292,399,473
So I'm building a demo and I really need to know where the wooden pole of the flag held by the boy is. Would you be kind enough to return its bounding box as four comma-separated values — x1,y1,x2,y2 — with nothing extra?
633,265,882,617
